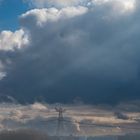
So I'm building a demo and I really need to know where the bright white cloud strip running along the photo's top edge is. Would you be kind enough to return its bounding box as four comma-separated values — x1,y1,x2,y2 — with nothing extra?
25,0,136,12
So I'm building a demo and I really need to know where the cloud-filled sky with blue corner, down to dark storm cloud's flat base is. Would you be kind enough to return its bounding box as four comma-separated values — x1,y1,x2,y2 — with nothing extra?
0,0,140,104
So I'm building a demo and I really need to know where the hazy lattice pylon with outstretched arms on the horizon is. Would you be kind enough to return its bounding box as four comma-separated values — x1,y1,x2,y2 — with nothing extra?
55,106,66,136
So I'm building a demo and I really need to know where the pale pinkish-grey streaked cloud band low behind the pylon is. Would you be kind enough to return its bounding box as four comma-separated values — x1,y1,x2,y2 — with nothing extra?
0,102,140,136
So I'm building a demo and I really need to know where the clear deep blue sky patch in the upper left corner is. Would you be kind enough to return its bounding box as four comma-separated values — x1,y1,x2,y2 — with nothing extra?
0,0,29,31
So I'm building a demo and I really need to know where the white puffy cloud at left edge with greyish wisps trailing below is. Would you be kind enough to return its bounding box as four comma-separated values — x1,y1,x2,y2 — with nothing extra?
0,29,29,80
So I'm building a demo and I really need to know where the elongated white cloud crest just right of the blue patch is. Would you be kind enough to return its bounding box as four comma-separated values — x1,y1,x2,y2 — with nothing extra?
21,6,88,27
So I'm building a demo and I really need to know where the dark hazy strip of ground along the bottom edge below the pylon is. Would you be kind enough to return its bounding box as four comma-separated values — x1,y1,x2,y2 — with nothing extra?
0,130,140,140
